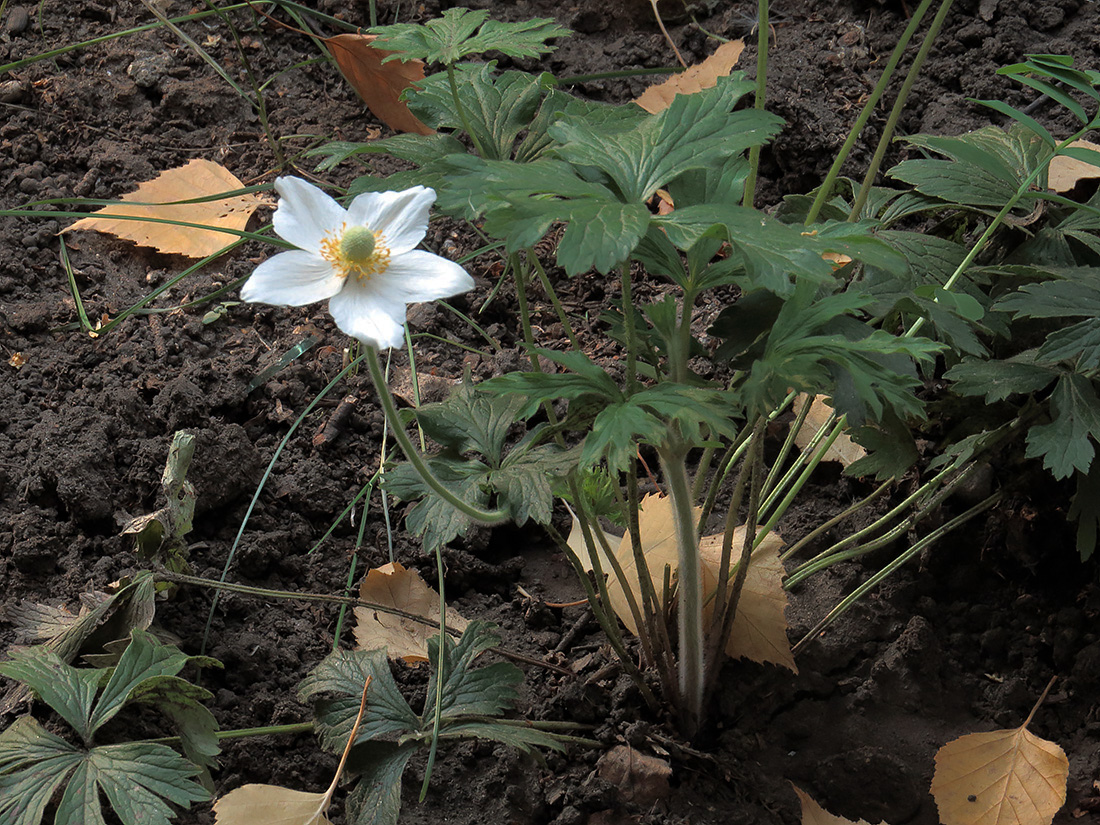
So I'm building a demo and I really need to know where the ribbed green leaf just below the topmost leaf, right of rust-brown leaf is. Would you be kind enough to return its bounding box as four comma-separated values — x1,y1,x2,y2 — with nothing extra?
408,63,546,161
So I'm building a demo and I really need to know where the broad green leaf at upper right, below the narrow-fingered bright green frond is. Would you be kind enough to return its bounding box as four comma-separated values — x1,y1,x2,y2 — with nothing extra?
890,127,1044,208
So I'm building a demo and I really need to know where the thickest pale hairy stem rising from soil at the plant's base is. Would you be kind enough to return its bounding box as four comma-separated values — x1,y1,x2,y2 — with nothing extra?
659,442,704,737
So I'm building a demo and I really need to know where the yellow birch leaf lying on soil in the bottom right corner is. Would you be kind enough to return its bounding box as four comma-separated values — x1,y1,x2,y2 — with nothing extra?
932,725,1069,825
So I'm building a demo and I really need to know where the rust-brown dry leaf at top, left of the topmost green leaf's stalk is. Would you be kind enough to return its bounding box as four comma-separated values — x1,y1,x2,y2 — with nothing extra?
325,34,435,134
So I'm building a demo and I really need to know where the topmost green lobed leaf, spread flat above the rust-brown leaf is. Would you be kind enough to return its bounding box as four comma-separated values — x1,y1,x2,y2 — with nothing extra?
370,9,571,65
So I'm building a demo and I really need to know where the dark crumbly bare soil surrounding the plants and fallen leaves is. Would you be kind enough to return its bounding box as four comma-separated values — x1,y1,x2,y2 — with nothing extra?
0,0,1100,825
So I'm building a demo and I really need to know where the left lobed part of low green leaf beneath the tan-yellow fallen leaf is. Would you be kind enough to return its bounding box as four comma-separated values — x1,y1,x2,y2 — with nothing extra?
298,649,420,754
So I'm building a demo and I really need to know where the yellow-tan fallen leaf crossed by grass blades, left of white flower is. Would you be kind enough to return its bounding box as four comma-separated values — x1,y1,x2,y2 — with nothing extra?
63,160,264,257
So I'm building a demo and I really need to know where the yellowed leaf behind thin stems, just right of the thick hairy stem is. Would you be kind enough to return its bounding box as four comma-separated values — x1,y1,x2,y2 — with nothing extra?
700,527,799,673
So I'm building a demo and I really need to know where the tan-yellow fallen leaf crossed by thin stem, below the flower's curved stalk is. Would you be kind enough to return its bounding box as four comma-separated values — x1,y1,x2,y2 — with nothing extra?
355,561,468,664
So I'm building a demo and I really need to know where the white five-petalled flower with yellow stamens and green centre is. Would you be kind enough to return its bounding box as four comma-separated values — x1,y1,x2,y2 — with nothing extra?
241,177,474,349
